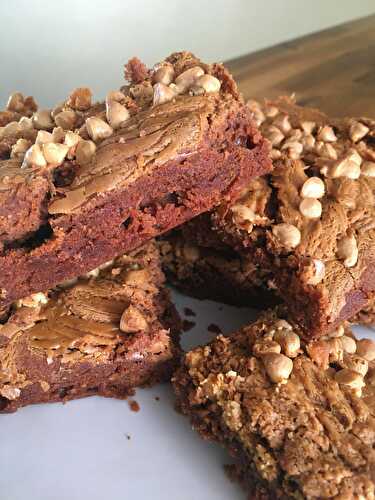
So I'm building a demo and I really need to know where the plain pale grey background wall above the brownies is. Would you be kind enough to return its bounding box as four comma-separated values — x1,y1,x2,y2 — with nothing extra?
0,0,375,107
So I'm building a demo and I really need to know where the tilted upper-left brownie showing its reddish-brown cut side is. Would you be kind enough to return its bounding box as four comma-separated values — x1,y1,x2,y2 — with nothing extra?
0,52,271,307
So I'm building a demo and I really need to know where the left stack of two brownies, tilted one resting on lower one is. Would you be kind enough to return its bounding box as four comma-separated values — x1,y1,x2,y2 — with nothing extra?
0,52,272,411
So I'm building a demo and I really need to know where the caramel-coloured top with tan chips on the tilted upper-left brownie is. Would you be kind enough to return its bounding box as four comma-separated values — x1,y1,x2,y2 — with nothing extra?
0,52,254,222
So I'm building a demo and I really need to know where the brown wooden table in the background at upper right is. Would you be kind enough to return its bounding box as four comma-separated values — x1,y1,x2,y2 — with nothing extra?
227,15,375,117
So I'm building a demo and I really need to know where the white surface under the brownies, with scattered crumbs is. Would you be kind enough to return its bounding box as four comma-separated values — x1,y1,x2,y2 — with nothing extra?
0,294,369,500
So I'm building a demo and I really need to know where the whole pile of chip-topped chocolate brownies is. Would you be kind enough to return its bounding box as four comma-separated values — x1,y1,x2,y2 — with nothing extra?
0,52,375,500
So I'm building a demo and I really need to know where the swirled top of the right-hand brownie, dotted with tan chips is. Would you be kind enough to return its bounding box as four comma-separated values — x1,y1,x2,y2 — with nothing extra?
215,98,375,317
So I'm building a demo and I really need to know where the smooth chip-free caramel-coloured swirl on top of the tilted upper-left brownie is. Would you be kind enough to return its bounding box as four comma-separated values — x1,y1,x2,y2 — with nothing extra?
49,96,213,214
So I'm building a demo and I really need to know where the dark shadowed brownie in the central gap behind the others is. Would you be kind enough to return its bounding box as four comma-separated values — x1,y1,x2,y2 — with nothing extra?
158,229,281,309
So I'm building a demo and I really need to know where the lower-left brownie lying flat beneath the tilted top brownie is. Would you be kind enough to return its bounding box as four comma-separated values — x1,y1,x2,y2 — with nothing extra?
0,242,180,412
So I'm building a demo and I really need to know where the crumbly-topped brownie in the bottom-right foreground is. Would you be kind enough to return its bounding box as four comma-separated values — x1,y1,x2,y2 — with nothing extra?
173,308,375,499
